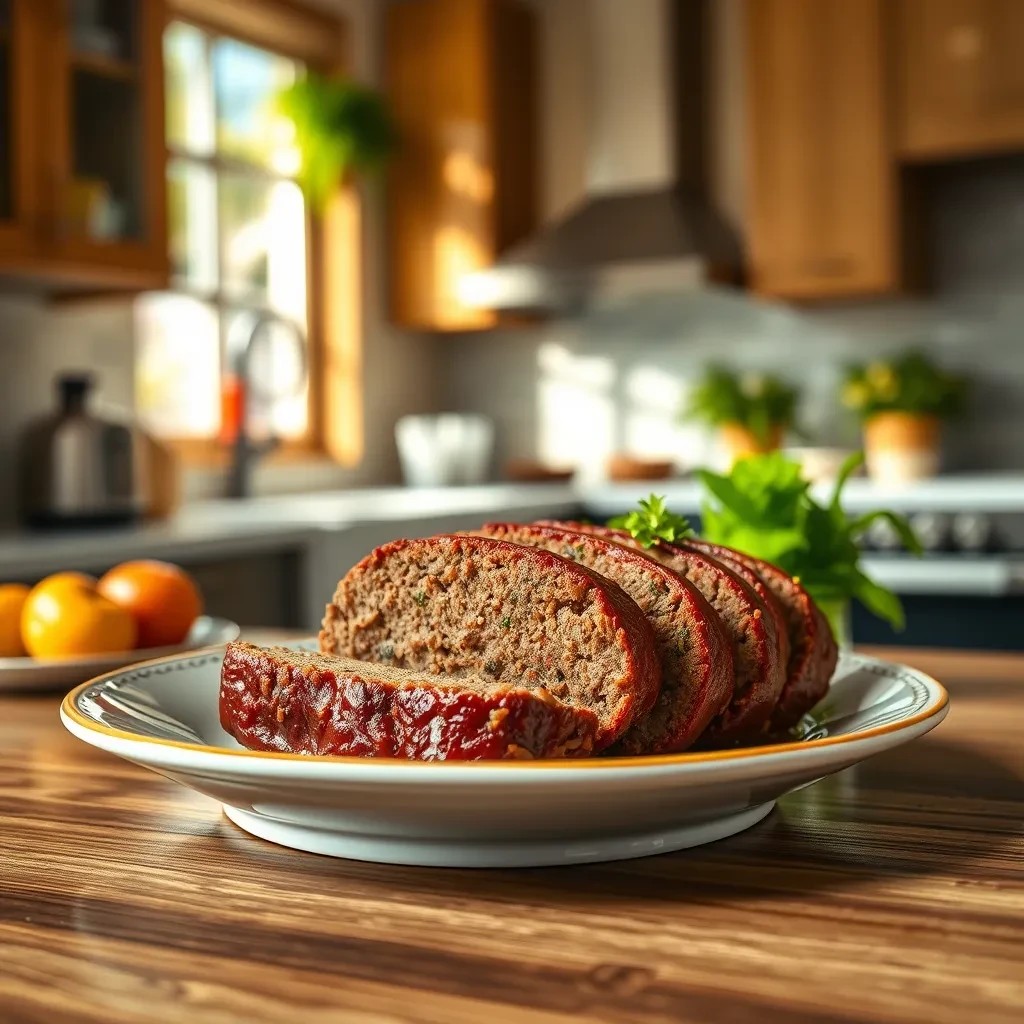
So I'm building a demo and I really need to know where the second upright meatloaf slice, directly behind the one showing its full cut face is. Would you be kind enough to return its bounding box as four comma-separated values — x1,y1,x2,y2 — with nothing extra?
481,523,734,754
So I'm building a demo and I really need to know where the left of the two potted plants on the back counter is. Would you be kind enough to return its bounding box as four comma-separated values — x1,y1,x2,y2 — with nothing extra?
683,366,799,462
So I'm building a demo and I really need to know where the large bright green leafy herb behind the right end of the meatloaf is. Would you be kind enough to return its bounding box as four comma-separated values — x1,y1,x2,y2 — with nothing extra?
698,452,922,629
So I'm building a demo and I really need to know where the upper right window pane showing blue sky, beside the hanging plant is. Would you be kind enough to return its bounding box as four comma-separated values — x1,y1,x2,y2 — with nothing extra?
213,39,299,174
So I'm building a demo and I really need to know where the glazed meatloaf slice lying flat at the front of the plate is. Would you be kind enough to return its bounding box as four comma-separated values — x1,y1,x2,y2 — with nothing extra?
220,643,597,761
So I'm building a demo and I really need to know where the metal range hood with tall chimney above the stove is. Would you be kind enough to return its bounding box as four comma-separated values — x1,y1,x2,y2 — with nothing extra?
460,0,740,310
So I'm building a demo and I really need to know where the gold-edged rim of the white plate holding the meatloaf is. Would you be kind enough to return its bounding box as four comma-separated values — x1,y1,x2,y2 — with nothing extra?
60,638,949,772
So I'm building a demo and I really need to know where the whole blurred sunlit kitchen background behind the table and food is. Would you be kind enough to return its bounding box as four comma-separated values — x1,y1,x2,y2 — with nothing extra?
0,0,1024,649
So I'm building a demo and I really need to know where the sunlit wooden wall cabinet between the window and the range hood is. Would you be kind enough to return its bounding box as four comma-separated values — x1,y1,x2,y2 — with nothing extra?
385,0,538,331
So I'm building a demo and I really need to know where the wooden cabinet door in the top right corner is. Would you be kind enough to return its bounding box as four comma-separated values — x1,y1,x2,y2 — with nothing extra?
894,0,1024,160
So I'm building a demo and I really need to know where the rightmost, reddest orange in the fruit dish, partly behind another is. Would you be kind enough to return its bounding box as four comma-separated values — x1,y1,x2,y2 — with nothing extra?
99,561,203,647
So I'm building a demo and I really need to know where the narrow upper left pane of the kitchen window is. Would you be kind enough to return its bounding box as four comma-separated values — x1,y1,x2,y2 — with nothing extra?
164,22,214,156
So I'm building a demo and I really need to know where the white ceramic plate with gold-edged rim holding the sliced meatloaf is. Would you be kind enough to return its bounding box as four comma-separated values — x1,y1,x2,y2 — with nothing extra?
60,644,948,867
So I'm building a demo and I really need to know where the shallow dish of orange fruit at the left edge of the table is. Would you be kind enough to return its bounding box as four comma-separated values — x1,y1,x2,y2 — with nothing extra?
0,560,239,691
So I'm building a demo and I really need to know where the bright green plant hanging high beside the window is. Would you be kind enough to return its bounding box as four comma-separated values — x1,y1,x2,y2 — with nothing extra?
276,73,397,211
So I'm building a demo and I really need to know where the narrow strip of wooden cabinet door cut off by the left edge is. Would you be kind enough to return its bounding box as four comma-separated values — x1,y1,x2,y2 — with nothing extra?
0,0,40,256
